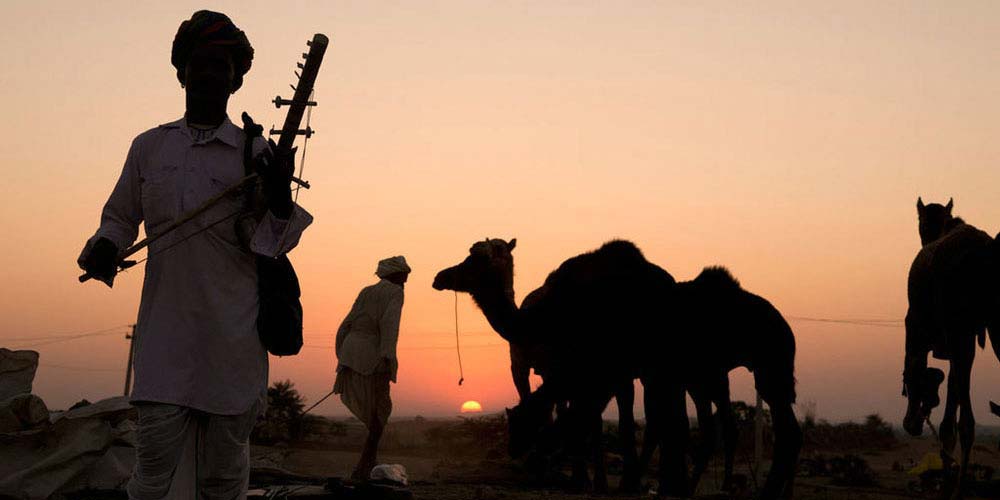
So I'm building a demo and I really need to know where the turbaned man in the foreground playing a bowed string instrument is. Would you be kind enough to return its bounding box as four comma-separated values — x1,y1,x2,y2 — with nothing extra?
79,10,311,500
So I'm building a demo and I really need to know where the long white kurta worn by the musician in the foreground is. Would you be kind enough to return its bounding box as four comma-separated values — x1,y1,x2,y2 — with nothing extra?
84,119,312,415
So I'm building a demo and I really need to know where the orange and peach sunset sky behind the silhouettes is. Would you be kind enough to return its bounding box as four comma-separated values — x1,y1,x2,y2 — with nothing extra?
0,1,1000,424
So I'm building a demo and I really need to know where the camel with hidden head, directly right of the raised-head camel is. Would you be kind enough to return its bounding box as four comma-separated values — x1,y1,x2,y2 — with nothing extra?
511,267,802,499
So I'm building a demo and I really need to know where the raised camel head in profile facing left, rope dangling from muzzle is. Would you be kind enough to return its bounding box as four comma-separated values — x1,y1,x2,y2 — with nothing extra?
434,238,517,300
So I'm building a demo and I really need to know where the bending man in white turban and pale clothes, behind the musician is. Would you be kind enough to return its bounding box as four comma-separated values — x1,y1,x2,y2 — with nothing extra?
333,256,410,480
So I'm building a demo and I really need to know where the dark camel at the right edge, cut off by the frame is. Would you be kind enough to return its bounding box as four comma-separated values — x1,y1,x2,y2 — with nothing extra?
903,198,1000,499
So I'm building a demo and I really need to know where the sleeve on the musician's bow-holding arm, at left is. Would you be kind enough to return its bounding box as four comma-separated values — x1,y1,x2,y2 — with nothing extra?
78,137,142,263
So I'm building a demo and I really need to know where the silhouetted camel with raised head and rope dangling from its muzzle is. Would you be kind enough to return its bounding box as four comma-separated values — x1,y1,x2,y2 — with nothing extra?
434,239,672,490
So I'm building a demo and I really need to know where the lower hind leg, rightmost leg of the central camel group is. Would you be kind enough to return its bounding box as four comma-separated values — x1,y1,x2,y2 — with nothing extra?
760,398,802,500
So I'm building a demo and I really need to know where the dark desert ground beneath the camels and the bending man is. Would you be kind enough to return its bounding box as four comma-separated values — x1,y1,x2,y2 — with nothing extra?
252,415,1000,500
